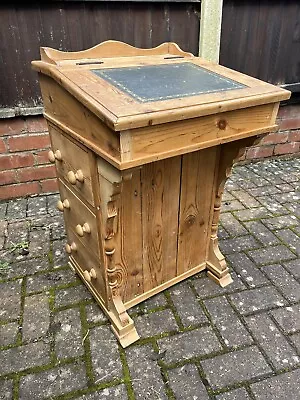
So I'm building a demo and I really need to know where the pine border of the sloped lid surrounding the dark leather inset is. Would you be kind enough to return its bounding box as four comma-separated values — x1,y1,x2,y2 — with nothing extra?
58,63,290,130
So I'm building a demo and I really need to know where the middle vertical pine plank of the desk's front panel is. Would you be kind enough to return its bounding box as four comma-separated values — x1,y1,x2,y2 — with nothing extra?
142,157,181,291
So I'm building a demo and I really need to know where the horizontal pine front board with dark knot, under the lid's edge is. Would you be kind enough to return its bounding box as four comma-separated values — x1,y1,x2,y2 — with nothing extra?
124,104,276,166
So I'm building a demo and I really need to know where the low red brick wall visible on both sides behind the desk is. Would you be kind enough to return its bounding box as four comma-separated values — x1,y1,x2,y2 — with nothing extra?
0,105,300,199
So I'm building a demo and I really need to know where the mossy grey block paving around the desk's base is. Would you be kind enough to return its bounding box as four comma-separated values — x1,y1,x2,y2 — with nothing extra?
0,159,300,400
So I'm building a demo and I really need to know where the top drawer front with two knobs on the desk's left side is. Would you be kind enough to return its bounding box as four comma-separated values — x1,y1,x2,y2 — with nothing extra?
49,125,94,205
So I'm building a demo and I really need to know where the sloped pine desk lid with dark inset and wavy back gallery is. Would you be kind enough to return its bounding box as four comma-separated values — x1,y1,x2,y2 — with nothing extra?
32,41,290,131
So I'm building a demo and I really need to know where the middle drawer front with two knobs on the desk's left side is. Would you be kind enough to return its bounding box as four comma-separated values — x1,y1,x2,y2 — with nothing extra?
58,179,99,255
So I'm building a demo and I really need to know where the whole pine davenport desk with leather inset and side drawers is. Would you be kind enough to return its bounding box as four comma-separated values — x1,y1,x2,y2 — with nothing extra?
32,41,290,347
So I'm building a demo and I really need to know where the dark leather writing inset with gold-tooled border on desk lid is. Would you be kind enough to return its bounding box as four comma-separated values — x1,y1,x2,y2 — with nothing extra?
92,62,246,103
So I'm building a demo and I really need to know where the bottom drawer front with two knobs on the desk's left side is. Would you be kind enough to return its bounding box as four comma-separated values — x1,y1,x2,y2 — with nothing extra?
66,229,107,304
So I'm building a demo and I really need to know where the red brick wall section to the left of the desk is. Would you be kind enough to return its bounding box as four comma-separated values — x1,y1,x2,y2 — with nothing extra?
0,117,57,199
